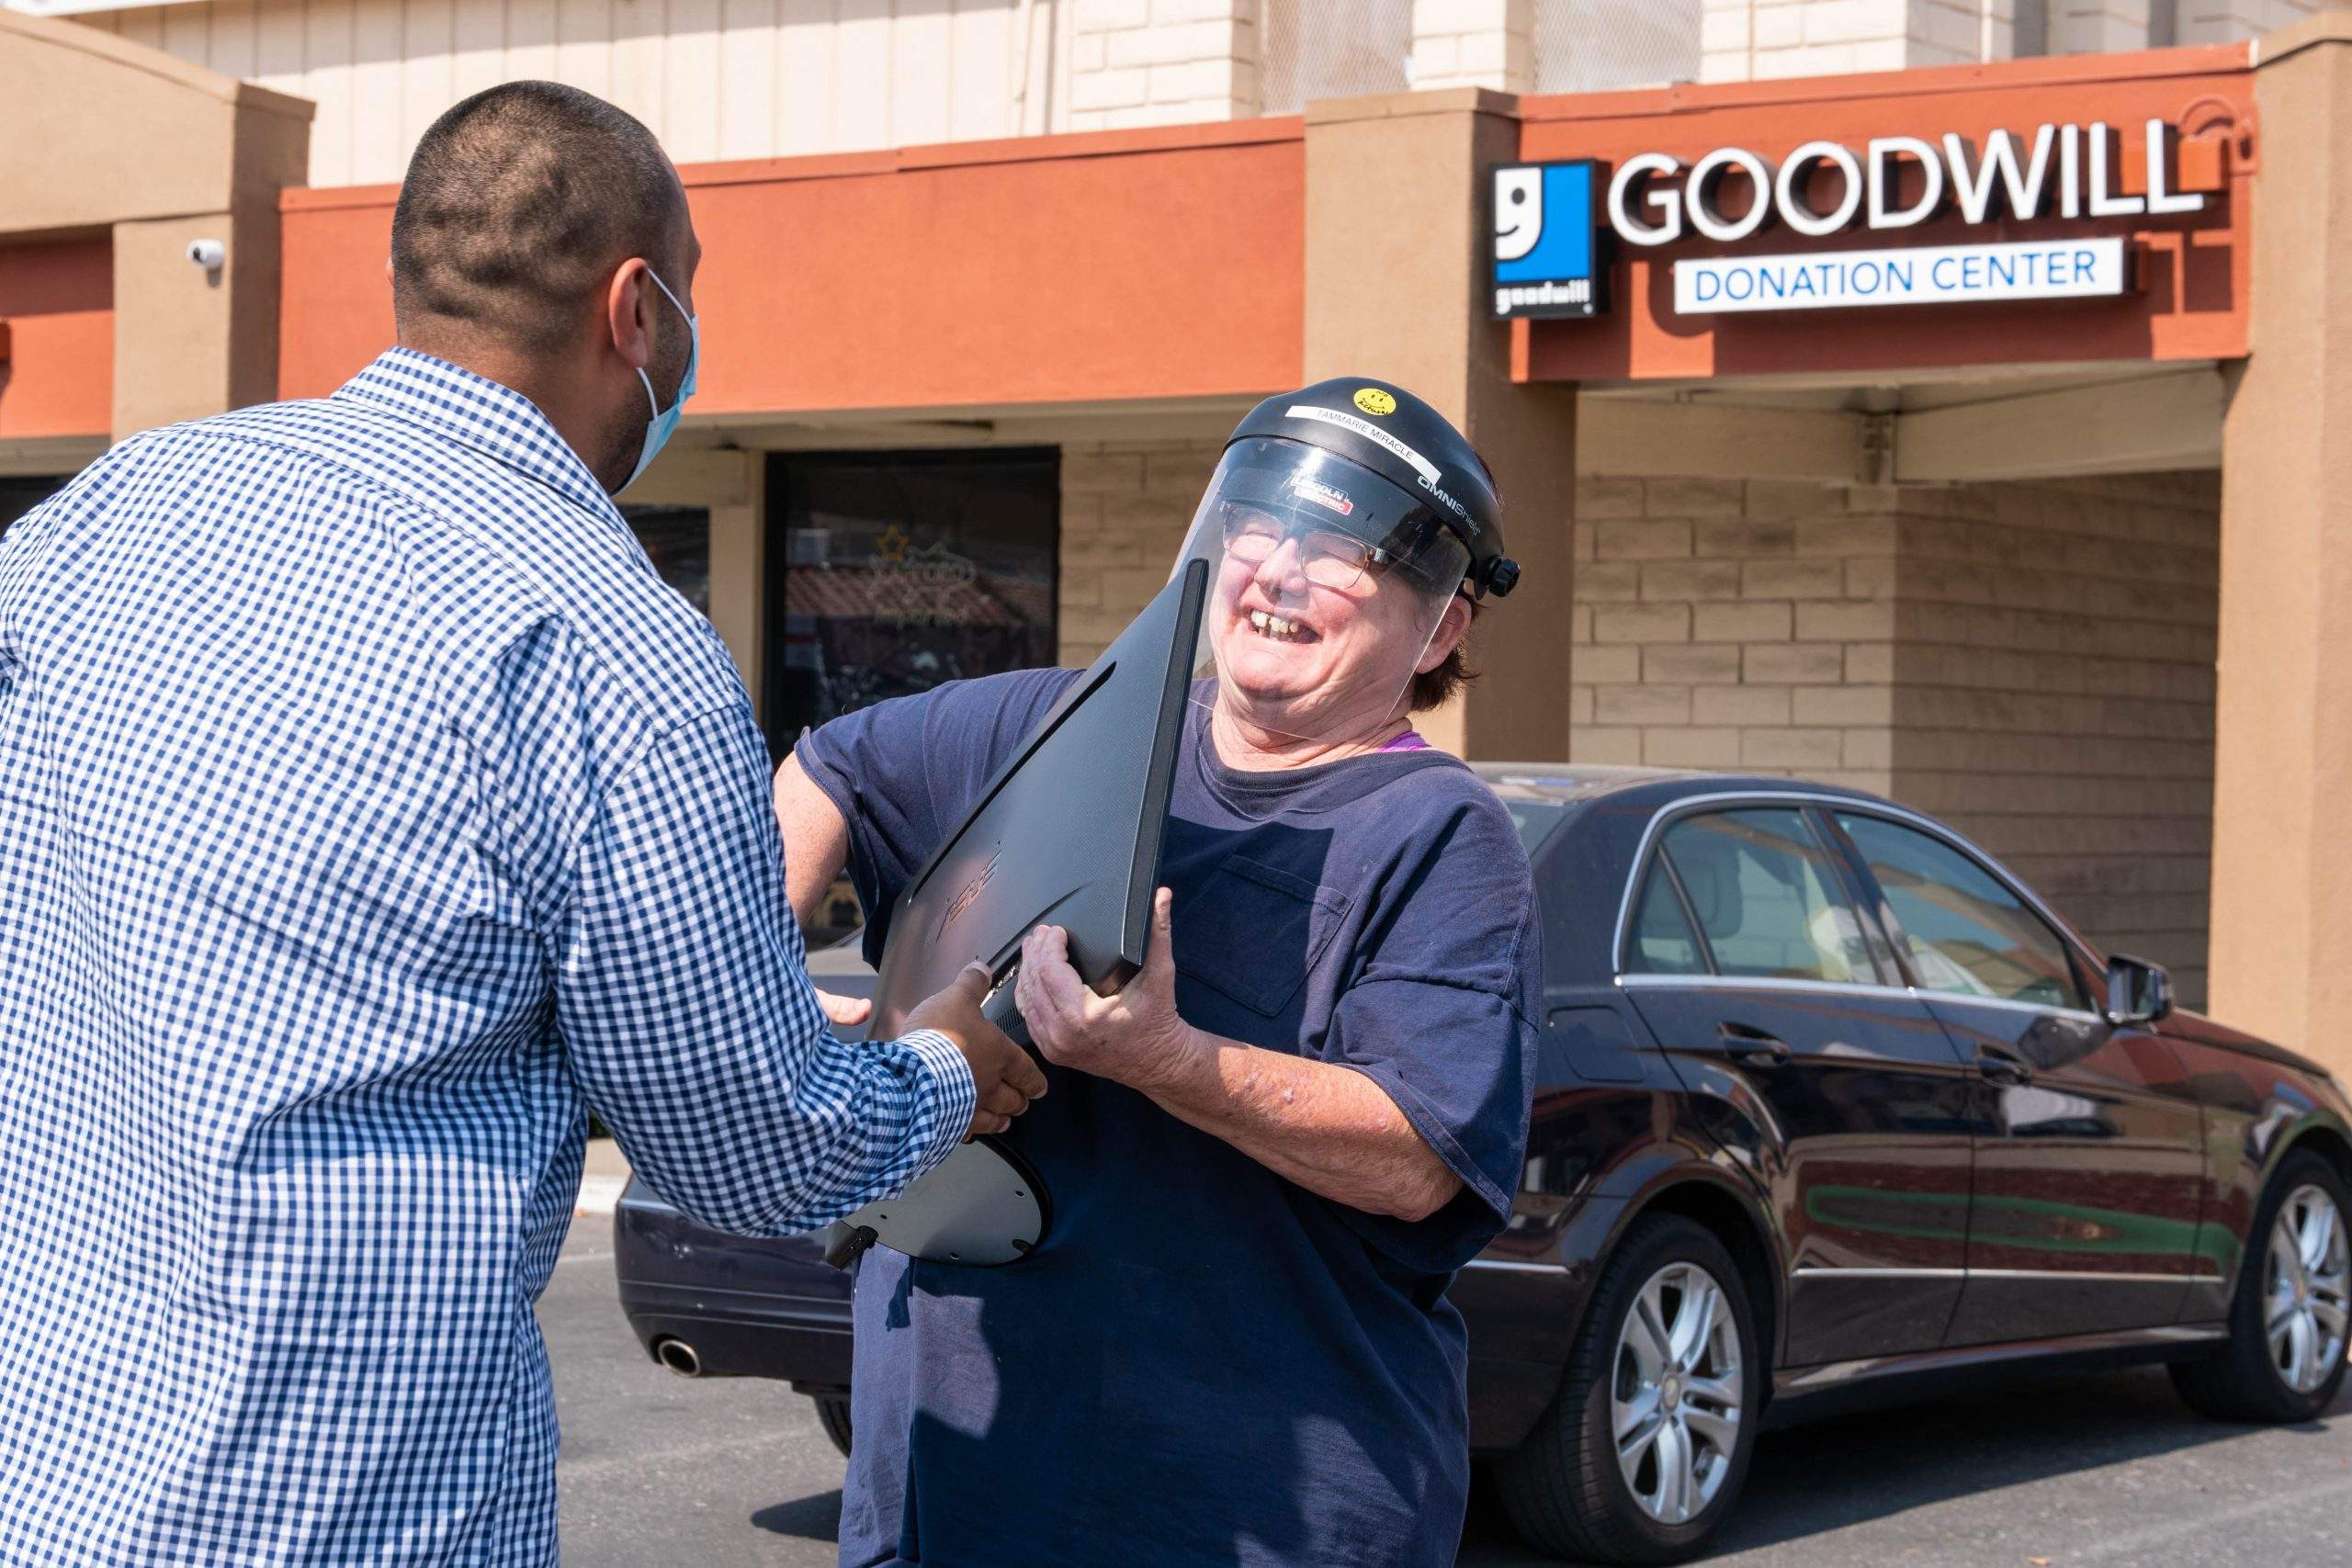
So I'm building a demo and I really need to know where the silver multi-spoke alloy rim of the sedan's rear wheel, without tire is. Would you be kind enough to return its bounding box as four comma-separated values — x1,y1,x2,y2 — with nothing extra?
1609,1262,1746,1523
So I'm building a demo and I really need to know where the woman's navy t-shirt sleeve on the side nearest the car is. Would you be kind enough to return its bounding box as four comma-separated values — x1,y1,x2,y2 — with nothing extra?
1324,807,1541,1274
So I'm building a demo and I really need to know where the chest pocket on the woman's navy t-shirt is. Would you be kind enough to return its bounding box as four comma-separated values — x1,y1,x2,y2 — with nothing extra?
1176,856,1348,1018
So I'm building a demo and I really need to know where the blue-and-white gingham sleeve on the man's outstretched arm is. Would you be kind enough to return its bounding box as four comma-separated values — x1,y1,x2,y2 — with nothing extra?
555,705,976,1236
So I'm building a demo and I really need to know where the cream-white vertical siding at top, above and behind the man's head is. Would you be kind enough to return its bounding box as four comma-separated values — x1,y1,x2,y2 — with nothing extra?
75,0,1081,186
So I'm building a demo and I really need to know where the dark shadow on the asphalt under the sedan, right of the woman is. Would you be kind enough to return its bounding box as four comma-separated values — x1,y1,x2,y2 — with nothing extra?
1463,1368,2352,1568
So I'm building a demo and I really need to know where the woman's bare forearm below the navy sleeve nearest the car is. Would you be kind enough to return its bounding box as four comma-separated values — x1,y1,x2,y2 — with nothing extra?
1146,1030,1463,1220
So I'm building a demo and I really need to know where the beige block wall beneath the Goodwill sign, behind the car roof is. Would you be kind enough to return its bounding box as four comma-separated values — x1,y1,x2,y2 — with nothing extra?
1569,475,2221,1006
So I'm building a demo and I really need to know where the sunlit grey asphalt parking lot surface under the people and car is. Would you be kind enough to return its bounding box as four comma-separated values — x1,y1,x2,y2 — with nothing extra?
538,1218,2352,1568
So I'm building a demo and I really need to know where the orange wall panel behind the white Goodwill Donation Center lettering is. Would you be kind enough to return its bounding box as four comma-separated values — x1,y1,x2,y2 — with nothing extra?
1512,45,2260,381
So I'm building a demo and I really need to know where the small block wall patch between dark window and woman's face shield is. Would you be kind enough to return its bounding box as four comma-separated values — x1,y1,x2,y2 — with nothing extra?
1056,442,1223,668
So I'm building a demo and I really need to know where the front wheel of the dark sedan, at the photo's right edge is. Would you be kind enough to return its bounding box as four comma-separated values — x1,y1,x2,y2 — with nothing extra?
2173,1149,2352,1422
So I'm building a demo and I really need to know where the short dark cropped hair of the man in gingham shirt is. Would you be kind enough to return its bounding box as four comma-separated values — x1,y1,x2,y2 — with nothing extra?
393,83,687,350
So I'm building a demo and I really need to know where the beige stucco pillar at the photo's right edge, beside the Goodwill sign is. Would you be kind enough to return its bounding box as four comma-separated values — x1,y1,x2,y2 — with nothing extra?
2213,12,2352,1077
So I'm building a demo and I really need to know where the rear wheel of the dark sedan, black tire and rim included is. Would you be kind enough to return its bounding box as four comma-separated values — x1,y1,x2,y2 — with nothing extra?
1496,1215,1764,1563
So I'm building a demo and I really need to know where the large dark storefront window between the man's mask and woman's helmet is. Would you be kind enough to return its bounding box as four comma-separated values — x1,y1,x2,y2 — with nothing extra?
767,449,1061,752
